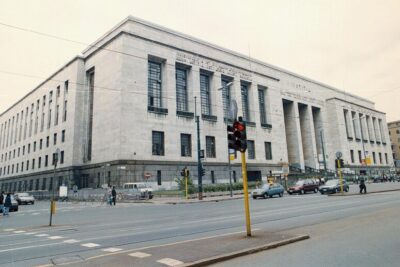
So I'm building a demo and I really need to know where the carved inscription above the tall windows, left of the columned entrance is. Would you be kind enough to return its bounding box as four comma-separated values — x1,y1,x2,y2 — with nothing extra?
176,52,252,81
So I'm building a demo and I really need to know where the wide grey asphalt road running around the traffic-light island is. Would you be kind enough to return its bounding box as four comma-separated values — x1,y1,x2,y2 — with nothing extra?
0,183,400,266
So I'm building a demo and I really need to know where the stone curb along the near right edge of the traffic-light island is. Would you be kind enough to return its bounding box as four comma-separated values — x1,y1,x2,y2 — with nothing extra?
178,235,310,267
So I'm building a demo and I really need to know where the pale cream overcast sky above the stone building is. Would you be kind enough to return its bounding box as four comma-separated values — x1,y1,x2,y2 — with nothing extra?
0,0,400,121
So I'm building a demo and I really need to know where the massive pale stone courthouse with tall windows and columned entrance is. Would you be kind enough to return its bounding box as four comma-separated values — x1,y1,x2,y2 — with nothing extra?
0,17,393,191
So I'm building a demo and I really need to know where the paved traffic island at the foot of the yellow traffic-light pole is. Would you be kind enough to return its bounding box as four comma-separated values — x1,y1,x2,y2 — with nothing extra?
62,230,309,267
